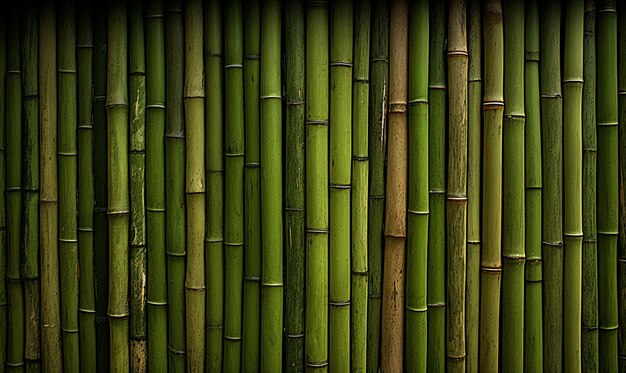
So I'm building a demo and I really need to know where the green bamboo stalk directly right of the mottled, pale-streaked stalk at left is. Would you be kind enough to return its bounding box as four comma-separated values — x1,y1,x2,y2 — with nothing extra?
144,1,167,372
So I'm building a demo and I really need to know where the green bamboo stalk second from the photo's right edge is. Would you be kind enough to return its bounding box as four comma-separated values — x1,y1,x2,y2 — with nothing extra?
596,0,619,372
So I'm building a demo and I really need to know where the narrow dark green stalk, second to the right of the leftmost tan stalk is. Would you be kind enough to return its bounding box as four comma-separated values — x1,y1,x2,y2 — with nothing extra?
76,3,97,372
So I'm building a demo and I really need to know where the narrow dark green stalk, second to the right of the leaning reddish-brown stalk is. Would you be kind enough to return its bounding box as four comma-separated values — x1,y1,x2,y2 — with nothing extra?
426,1,447,372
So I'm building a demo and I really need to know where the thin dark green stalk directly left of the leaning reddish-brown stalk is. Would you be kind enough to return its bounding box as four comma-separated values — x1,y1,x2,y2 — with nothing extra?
367,0,389,373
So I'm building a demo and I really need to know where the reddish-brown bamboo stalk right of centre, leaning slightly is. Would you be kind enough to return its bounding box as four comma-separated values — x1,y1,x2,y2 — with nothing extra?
380,0,409,372
